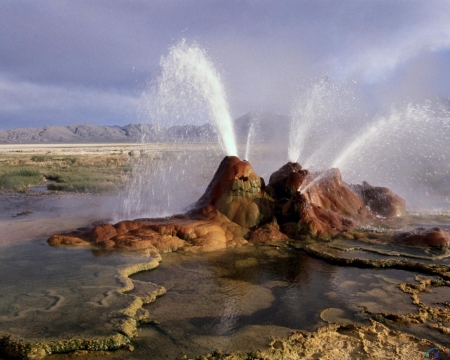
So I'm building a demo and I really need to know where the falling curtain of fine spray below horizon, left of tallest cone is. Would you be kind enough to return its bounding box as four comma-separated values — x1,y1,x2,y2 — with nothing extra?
114,148,222,222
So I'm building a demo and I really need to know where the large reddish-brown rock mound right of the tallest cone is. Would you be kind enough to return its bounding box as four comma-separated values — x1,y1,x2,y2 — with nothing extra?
266,163,368,238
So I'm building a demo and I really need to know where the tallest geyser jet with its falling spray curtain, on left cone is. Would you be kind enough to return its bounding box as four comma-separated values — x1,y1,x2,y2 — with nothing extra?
115,40,237,221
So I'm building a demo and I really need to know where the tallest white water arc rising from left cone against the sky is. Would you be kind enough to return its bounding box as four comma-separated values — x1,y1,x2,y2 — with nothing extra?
147,40,238,156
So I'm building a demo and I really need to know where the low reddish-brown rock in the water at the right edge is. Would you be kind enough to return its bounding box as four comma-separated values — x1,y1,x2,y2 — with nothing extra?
394,227,450,247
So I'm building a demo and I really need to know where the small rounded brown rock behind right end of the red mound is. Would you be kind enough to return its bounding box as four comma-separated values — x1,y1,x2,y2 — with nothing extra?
351,181,406,217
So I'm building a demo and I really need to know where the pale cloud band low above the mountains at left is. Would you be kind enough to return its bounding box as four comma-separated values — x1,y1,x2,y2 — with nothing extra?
0,77,139,129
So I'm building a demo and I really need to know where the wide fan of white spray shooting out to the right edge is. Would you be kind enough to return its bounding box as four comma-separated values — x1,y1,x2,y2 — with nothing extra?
332,103,450,208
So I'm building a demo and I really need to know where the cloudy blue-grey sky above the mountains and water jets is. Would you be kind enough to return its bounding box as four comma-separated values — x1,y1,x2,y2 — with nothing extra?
0,0,450,129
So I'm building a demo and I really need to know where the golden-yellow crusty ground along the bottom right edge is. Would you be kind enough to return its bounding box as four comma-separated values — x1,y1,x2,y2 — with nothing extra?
196,321,450,360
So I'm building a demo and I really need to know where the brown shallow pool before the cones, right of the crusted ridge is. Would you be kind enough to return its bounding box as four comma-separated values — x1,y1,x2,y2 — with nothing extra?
128,246,415,359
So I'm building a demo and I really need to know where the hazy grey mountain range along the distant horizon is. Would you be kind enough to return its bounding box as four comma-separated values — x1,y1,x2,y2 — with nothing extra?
0,113,289,144
